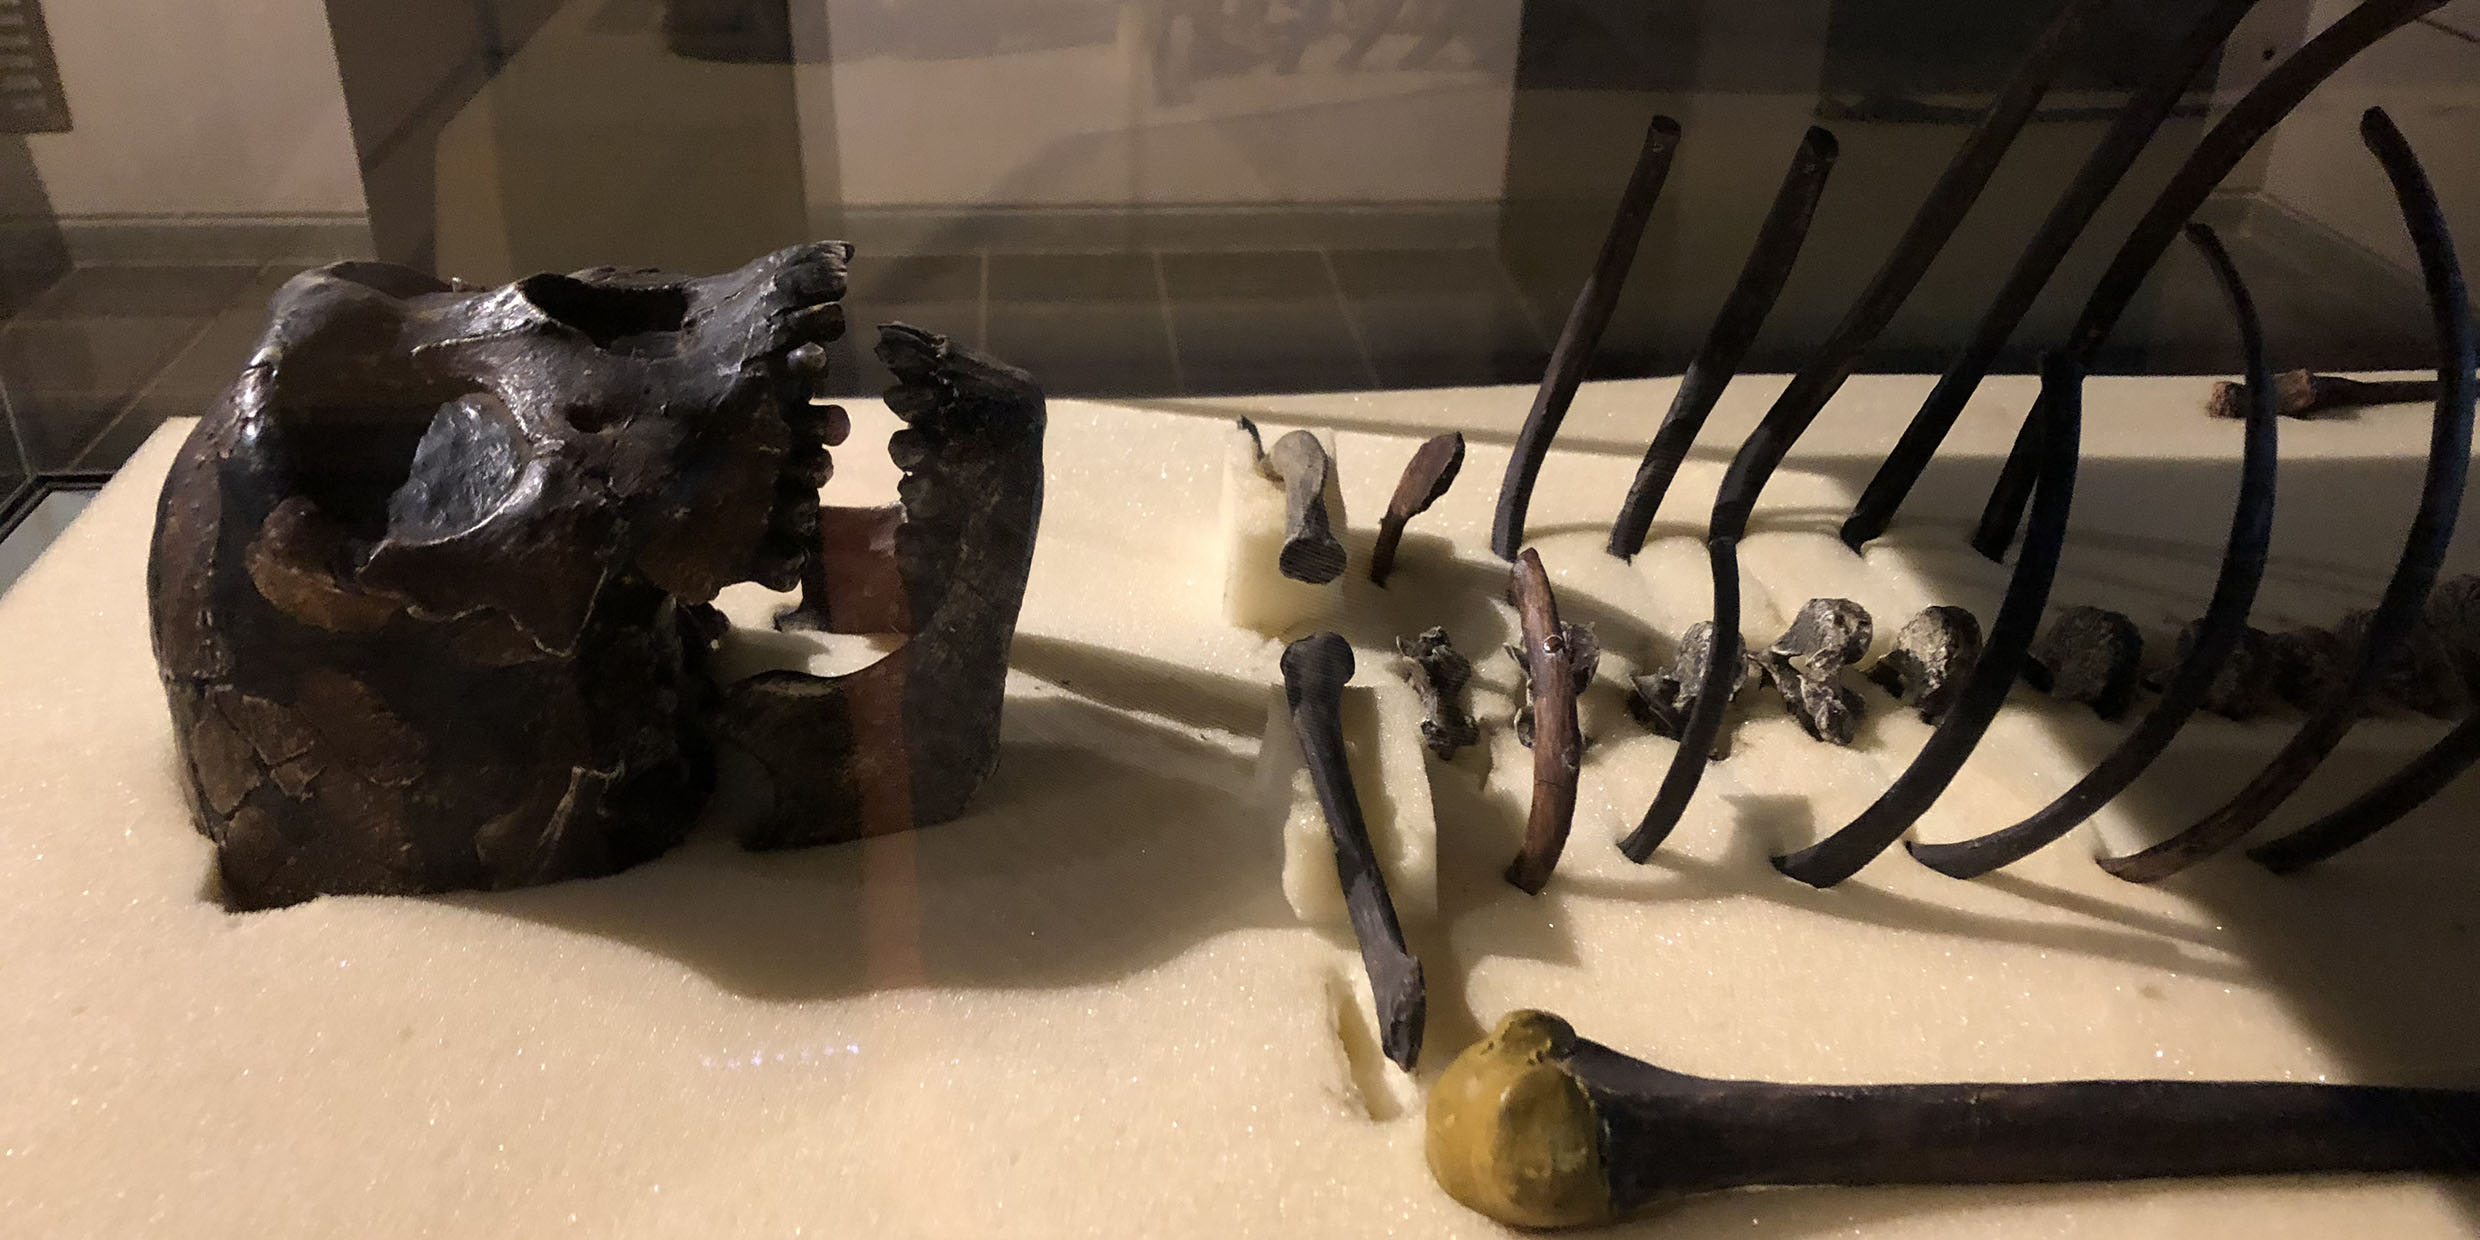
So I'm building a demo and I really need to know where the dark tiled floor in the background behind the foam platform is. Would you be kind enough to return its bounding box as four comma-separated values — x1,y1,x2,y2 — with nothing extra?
0,233,2418,503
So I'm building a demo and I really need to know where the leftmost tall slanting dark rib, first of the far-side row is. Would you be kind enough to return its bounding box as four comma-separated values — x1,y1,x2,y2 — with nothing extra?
1490,114,1679,563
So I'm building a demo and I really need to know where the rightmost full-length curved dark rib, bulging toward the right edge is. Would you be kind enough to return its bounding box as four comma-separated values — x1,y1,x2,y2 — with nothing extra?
2101,107,2473,883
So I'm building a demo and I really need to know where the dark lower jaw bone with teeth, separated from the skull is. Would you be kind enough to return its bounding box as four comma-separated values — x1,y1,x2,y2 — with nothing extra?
719,325,1044,848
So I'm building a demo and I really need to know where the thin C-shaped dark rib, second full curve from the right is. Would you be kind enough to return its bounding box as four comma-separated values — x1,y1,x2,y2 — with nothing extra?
1910,223,2282,878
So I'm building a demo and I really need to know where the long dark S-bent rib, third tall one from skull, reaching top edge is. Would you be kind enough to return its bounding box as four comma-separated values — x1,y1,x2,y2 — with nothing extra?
1619,0,2108,861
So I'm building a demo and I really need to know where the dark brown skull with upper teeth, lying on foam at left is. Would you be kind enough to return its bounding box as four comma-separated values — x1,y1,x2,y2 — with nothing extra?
149,243,1042,908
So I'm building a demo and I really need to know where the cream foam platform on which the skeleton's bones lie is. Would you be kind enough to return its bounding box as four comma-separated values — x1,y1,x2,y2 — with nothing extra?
0,377,2480,1240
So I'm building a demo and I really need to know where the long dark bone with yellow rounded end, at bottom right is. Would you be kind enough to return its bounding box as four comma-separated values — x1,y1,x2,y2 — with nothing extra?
1426,1012,2480,1228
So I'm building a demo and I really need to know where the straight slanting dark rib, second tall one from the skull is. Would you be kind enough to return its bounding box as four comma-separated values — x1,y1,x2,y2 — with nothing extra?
1610,129,1838,560
